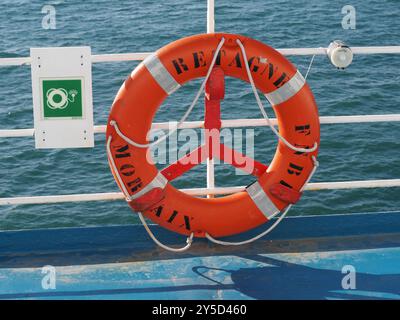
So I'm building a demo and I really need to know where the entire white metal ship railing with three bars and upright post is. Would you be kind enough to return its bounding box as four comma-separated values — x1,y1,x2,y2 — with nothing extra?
0,0,400,206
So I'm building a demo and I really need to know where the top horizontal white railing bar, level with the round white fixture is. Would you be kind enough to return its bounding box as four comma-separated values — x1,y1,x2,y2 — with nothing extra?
0,46,400,66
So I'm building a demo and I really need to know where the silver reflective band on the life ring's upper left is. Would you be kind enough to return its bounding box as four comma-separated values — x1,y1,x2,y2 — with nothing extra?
143,54,181,95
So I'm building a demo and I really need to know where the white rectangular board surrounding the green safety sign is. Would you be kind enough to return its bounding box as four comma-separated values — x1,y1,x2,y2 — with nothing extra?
30,47,94,149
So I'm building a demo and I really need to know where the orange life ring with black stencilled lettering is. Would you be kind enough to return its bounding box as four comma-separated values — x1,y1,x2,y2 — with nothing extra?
106,33,320,237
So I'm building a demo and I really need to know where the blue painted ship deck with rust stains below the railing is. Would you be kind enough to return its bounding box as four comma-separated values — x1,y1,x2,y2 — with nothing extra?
0,213,400,299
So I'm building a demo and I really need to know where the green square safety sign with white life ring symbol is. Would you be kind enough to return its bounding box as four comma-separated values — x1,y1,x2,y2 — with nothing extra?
42,79,83,119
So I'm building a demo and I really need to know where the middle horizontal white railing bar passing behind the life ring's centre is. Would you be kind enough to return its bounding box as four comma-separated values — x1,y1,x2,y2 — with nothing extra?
0,114,400,138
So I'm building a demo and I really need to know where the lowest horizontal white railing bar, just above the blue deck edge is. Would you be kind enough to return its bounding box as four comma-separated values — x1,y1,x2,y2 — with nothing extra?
0,179,400,206
